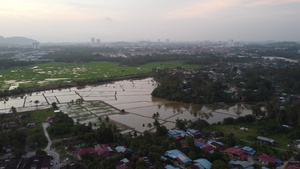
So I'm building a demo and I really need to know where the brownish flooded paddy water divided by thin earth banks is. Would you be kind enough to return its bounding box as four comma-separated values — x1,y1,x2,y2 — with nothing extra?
0,78,252,132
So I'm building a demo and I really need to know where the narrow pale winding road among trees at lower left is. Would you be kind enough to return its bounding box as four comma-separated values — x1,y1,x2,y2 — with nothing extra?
43,122,60,169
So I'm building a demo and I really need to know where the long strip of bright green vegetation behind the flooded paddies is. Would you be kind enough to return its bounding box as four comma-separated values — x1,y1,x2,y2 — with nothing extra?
0,60,199,93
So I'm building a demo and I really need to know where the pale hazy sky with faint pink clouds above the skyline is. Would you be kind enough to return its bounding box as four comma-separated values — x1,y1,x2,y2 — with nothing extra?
0,0,300,42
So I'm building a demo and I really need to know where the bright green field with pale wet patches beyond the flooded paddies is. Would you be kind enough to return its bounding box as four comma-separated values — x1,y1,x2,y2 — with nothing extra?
0,62,199,90
